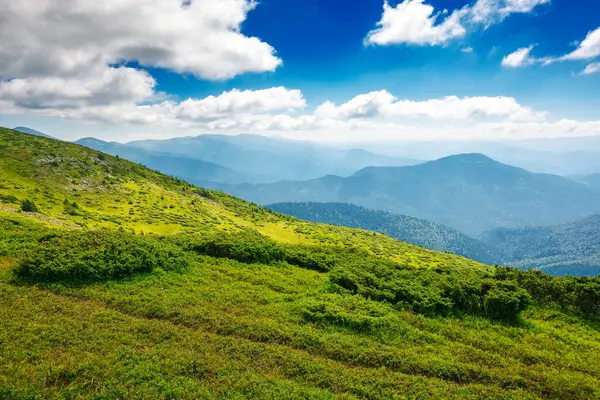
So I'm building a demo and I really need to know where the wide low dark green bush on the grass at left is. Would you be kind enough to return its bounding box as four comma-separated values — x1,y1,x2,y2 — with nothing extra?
16,230,188,281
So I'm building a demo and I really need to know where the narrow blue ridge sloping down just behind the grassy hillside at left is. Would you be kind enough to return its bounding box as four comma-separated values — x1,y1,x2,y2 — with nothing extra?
75,138,253,186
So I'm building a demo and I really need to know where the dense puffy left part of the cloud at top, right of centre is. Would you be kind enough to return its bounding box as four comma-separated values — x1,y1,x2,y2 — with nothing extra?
366,0,466,46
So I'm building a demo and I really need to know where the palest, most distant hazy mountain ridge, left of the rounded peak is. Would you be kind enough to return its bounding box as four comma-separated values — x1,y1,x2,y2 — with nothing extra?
127,135,419,182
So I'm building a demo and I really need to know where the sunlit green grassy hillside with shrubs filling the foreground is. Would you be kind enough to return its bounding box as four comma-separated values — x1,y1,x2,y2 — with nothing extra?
0,129,600,399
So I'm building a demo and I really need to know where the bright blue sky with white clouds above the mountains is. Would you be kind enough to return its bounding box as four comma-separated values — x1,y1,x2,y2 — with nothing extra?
0,0,600,142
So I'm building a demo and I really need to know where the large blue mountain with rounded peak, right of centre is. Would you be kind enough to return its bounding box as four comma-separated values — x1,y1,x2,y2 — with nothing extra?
220,154,600,235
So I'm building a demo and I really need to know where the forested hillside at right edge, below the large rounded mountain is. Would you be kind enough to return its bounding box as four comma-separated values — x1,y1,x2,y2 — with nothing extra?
479,215,600,276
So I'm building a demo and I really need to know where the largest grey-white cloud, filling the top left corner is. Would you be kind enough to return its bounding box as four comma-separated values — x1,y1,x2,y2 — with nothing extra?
0,0,281,79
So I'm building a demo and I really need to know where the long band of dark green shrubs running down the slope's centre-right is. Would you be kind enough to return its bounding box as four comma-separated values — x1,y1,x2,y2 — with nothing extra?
178,231,531,320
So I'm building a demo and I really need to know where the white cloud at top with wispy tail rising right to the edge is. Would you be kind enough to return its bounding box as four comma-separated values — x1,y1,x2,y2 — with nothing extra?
365,0,550,46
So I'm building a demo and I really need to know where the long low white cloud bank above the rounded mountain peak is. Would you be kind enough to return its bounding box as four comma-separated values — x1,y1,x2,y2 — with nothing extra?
315,90,545,121
